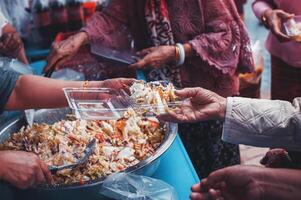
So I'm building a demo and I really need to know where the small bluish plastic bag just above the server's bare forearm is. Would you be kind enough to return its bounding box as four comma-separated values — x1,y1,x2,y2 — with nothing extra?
51,68,85,81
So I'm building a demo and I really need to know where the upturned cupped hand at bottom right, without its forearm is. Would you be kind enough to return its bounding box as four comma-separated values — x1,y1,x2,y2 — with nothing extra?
190,165,264,200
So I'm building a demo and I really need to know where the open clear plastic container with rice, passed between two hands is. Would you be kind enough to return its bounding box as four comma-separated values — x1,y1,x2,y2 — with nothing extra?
64,81,183,120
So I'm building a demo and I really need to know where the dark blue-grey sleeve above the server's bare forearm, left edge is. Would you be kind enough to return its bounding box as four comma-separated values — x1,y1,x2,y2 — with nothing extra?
0,68,20,114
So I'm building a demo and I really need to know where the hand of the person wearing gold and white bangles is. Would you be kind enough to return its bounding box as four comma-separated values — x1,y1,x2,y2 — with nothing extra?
130,46,176,69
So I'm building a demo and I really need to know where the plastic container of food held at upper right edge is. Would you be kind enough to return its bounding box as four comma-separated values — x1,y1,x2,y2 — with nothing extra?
284,15,301,42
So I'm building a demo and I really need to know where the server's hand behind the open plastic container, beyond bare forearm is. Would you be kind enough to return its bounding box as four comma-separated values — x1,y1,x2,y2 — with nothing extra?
98,78,137,90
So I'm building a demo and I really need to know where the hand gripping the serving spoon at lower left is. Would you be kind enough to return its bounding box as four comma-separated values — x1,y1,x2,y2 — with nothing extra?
0,151,53,189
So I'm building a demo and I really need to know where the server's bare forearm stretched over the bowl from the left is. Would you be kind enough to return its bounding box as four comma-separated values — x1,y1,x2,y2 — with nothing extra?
6,75,97,110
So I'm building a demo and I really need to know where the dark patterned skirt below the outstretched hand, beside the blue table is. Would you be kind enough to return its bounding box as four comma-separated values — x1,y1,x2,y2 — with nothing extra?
179,121,240,178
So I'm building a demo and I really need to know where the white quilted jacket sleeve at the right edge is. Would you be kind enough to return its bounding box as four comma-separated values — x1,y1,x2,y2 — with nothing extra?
222,97,301,151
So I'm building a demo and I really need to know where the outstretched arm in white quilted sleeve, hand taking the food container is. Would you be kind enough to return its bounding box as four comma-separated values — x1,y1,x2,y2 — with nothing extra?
159,88,301,151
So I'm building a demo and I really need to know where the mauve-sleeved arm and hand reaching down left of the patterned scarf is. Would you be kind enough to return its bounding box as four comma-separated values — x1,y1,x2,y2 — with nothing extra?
44,0,128,72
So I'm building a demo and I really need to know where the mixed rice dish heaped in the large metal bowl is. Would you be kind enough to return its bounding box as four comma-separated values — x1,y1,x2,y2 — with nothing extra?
0,110,165,184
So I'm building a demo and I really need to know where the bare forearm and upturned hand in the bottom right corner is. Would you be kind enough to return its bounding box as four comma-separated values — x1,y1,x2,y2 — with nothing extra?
190,166,301,200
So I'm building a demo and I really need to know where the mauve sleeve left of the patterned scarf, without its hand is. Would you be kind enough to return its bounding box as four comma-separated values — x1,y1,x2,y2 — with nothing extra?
82,0,128,43
